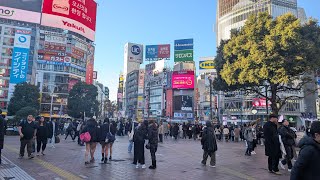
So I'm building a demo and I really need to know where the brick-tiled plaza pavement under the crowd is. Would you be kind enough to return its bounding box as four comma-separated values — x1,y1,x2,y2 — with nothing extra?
0,137,289,180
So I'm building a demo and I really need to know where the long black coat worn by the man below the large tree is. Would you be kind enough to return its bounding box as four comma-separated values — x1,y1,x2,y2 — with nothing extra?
263,121,281,157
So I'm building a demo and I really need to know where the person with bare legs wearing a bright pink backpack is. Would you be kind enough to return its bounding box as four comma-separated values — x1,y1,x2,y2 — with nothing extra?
81,118,99,165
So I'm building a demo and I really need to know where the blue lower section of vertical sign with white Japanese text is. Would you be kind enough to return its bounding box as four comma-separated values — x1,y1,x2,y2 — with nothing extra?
10,47,29,84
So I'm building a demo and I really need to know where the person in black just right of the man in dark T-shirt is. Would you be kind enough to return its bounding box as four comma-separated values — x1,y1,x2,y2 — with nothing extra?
36,116,49,156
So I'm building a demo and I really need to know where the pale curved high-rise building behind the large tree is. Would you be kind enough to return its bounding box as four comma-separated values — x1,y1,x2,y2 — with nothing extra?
216,0,315,126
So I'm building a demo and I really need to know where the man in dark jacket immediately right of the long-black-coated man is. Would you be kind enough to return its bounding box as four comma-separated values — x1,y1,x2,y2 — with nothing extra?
279,119,296,172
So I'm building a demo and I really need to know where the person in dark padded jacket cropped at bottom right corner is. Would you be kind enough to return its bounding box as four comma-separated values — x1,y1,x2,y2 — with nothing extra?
290,121,320,180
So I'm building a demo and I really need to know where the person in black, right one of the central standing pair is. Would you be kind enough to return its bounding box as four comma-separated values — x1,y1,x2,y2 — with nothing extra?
148,121,158,169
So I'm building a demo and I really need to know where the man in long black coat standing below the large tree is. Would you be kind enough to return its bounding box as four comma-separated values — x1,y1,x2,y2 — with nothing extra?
263,114,281,175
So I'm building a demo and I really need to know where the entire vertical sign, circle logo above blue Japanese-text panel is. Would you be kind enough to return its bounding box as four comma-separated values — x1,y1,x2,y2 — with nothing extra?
10,29,31,84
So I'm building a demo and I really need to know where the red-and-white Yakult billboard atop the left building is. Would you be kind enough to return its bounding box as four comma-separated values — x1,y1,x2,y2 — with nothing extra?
41,0,97,41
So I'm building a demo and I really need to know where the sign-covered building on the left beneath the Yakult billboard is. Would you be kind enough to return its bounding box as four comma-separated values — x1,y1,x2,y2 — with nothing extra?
0,0,97,118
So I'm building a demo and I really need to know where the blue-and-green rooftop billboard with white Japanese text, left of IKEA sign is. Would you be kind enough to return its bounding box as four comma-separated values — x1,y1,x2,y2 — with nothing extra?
174,39,193,62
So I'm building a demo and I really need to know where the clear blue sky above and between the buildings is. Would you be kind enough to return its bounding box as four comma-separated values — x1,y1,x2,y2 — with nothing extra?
95,0,320,100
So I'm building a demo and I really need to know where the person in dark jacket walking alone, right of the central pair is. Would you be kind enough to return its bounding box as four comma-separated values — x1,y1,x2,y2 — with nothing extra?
201,121,218,167
